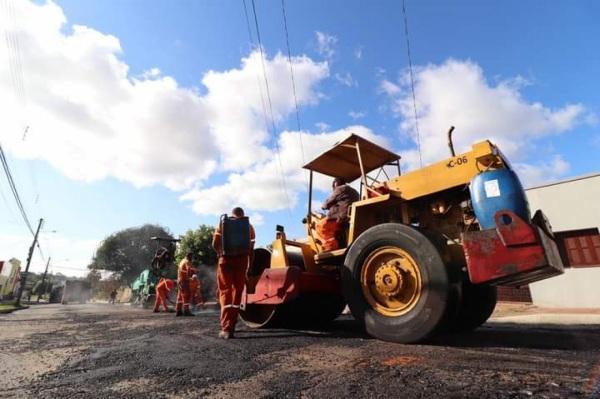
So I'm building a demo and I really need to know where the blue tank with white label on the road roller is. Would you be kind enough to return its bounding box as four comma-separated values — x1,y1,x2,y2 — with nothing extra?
469,169,531,229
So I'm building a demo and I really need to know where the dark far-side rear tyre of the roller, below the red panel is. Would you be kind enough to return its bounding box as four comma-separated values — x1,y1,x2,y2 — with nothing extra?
450,281,498,332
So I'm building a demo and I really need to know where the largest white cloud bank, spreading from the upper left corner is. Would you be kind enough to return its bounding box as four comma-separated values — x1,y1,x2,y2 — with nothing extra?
0,1,329,190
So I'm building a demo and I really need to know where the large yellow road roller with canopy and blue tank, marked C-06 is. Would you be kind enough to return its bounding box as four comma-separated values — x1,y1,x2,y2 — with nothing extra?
241,129,563,343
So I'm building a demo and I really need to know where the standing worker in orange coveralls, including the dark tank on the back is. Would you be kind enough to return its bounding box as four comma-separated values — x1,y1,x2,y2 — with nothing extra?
213,207,256,339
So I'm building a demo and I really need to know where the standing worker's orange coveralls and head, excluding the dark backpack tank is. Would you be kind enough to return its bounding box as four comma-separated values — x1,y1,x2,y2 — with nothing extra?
213,207,256,339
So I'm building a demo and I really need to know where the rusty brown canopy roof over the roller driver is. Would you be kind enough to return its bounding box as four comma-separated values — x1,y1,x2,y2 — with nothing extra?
304,133,400,182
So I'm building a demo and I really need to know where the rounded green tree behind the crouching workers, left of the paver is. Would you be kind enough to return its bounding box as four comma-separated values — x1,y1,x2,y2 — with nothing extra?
88,224,173,284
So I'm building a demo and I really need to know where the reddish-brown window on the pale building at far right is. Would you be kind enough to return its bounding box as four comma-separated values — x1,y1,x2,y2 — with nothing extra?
555,228,600,267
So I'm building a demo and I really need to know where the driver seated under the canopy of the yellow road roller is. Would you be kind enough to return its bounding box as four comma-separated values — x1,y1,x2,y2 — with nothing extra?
316,177,360,251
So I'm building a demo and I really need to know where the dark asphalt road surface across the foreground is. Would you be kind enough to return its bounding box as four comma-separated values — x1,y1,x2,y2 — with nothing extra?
0,305,600,399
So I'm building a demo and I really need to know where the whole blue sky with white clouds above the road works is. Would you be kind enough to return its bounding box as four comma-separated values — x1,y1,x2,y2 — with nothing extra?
0,0,600,273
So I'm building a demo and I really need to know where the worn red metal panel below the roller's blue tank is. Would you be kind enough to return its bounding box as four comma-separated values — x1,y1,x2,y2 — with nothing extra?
463,211,562,286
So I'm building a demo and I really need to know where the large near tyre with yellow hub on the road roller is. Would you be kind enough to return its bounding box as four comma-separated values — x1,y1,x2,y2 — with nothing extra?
342,223,458,343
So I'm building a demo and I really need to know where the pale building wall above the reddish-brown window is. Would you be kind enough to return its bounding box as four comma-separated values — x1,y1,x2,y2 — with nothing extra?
525,174,600,231
